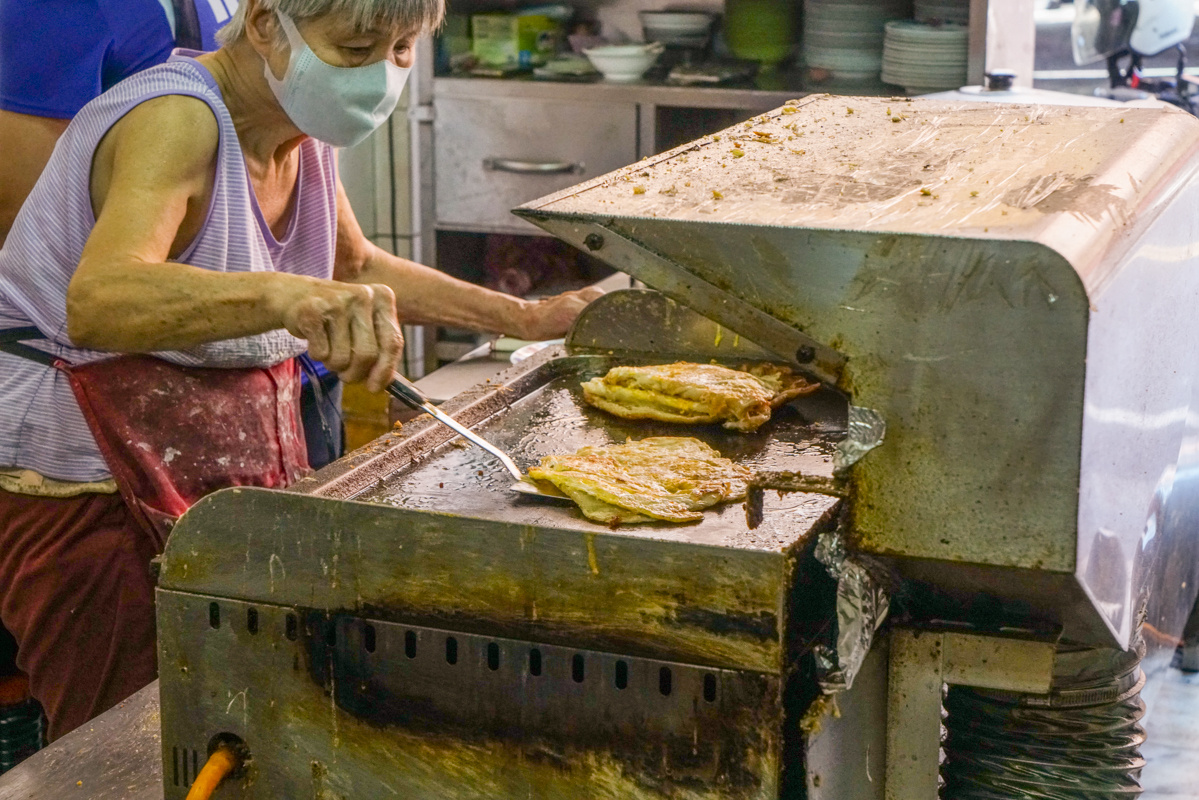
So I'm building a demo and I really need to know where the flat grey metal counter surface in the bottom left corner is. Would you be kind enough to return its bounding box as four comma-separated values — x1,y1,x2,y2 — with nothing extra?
0,681,163,800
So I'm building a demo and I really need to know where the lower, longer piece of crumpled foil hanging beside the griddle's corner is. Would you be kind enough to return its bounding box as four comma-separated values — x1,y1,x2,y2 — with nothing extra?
813,531,891,694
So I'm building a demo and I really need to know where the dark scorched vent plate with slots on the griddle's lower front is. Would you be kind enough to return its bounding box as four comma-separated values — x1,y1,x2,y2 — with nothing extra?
309,616,764,758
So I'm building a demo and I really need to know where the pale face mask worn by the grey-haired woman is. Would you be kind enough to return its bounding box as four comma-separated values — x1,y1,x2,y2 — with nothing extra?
264,11,411,148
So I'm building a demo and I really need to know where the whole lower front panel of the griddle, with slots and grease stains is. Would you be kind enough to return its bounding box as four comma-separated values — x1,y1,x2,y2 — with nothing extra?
157,590,782,800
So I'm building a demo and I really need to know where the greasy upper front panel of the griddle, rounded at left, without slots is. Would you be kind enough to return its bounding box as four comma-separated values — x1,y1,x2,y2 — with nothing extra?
159,489,836,673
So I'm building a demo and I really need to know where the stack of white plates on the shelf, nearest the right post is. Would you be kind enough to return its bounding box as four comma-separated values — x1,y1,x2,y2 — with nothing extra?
882,19,969,95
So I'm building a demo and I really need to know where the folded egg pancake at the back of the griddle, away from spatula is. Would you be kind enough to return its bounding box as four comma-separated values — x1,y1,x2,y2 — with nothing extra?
583,361,820,432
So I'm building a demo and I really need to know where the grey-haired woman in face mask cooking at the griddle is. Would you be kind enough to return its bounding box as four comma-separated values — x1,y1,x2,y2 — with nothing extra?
0,0,592,738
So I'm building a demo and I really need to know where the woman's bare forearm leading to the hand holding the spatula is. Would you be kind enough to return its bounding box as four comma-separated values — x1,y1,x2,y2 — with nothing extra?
67,263,304,353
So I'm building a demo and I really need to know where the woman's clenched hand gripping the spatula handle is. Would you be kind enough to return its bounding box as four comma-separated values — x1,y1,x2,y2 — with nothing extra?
273,279,404,392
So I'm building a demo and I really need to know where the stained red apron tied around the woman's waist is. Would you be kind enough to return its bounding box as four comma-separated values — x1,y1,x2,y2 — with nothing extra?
55,355,309,541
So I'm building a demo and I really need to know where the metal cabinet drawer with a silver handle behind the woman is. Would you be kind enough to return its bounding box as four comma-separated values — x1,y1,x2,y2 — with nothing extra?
433,97,637,233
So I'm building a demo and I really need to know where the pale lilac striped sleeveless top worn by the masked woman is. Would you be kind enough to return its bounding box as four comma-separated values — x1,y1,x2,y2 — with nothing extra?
0,52,337,482
